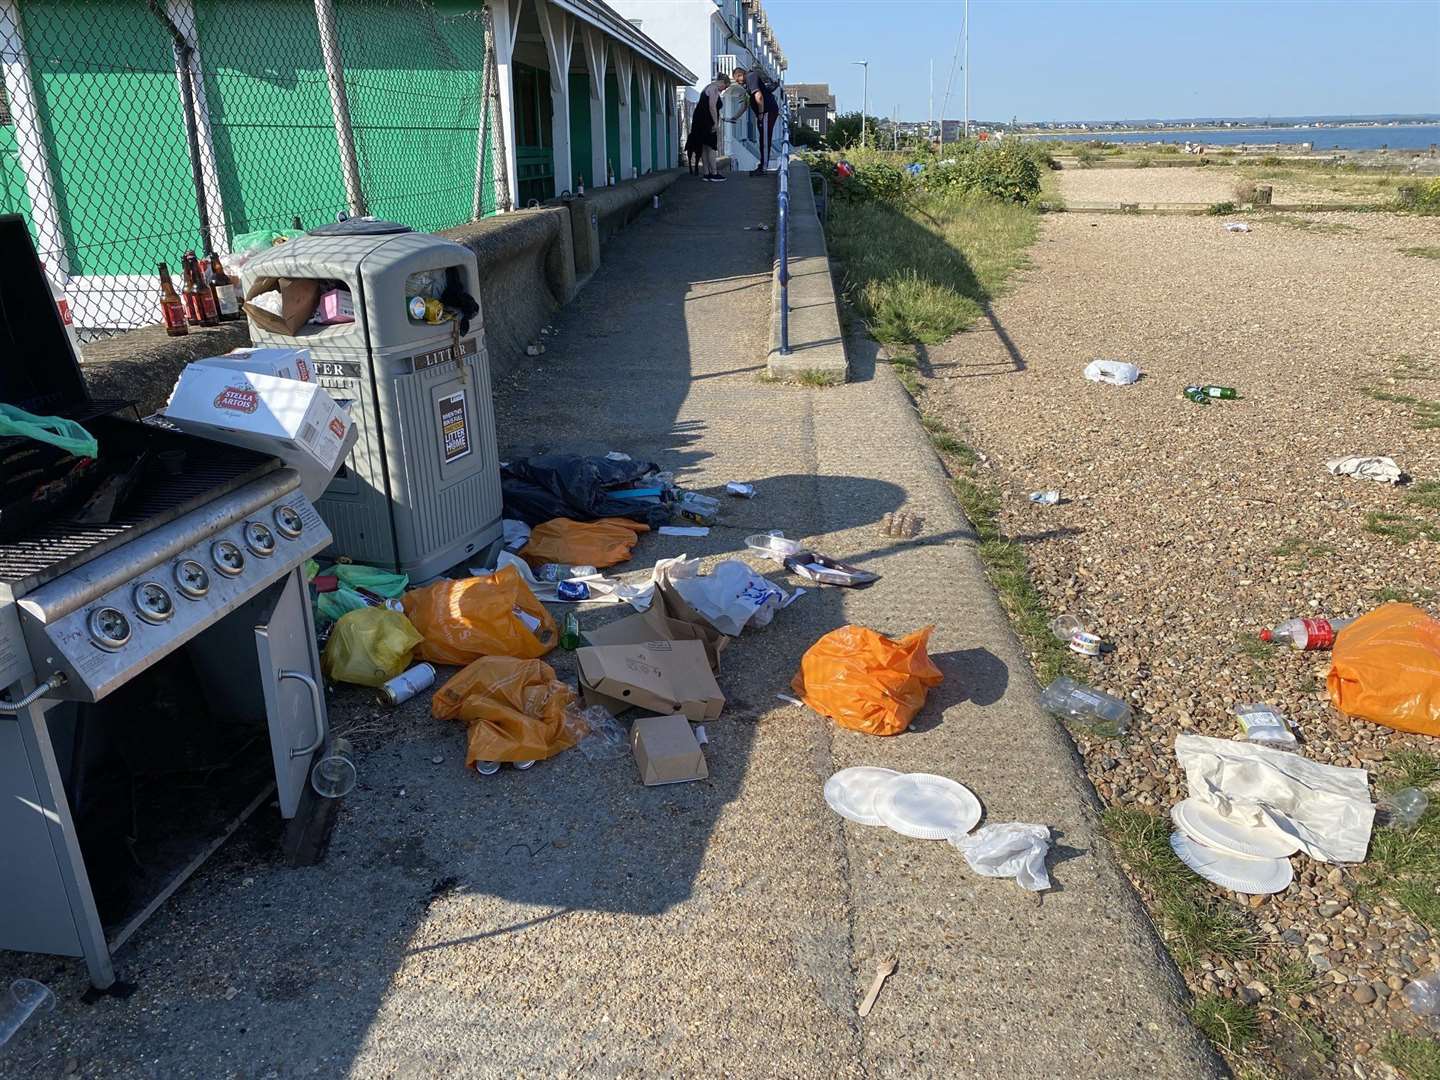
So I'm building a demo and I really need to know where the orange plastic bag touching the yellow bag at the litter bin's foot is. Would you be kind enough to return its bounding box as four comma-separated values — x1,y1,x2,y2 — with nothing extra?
400,566,559,664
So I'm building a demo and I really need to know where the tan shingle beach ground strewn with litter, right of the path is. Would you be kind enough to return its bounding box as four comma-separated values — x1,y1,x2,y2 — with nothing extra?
922,204,1440,1077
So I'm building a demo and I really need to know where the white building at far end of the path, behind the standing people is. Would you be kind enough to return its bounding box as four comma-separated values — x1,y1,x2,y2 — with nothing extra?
609,0,788,170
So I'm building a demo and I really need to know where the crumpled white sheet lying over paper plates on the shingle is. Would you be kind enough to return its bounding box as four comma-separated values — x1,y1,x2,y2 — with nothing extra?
1175,734,1375,863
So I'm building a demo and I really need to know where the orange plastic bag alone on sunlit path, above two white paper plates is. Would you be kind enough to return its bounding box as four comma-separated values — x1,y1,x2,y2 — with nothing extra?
791,626,945,734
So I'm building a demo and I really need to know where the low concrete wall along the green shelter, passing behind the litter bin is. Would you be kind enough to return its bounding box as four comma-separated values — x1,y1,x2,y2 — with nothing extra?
82,168,680,415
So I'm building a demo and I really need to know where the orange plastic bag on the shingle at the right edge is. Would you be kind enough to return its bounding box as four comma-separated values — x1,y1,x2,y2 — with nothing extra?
1325,603,1440,736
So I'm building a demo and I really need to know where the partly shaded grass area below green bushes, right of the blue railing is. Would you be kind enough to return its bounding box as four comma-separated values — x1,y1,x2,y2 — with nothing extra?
827,194,1038,346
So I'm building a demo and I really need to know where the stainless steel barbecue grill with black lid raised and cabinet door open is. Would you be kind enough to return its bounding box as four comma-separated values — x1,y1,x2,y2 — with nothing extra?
0,216,331,988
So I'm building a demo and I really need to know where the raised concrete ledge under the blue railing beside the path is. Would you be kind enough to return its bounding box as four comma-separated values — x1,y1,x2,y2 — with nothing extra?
766,161,850,383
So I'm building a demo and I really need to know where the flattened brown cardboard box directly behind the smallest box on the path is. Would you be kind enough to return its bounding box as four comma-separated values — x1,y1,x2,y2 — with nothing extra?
575,641,724,724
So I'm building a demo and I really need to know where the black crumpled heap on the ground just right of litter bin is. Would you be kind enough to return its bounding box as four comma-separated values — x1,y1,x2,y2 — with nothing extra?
500,454,670,527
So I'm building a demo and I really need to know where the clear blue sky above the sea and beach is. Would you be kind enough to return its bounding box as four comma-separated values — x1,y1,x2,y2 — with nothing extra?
765,0,1440,121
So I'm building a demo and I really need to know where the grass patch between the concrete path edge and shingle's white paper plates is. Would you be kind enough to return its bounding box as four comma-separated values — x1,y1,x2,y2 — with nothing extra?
1102,806,1256,967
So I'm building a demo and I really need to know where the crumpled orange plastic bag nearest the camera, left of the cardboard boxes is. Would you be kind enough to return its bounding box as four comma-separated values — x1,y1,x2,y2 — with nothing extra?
431,657,575,766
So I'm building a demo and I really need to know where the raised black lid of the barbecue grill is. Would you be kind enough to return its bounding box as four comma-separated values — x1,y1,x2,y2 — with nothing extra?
0,213,89,415
